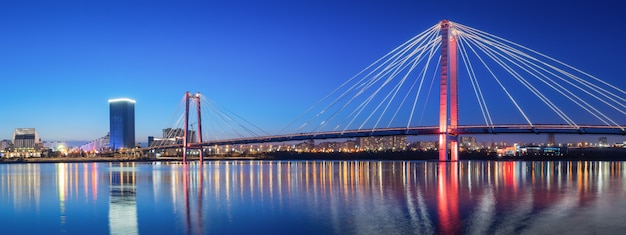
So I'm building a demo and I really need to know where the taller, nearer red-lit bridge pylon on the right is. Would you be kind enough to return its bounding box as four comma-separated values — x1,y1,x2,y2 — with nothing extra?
438,20,459,161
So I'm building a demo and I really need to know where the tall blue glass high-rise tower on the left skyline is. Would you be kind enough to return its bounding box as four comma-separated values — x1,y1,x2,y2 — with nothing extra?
109,98,135,150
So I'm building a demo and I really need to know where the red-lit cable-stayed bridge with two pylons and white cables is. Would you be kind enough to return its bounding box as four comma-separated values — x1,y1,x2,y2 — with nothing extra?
147,20,626,161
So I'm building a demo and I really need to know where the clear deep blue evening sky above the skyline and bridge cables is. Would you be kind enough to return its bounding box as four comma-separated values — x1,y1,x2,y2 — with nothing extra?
0,0,626,142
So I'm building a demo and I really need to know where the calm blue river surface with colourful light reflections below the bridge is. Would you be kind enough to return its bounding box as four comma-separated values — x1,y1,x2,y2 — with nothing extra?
0,161,626,234
